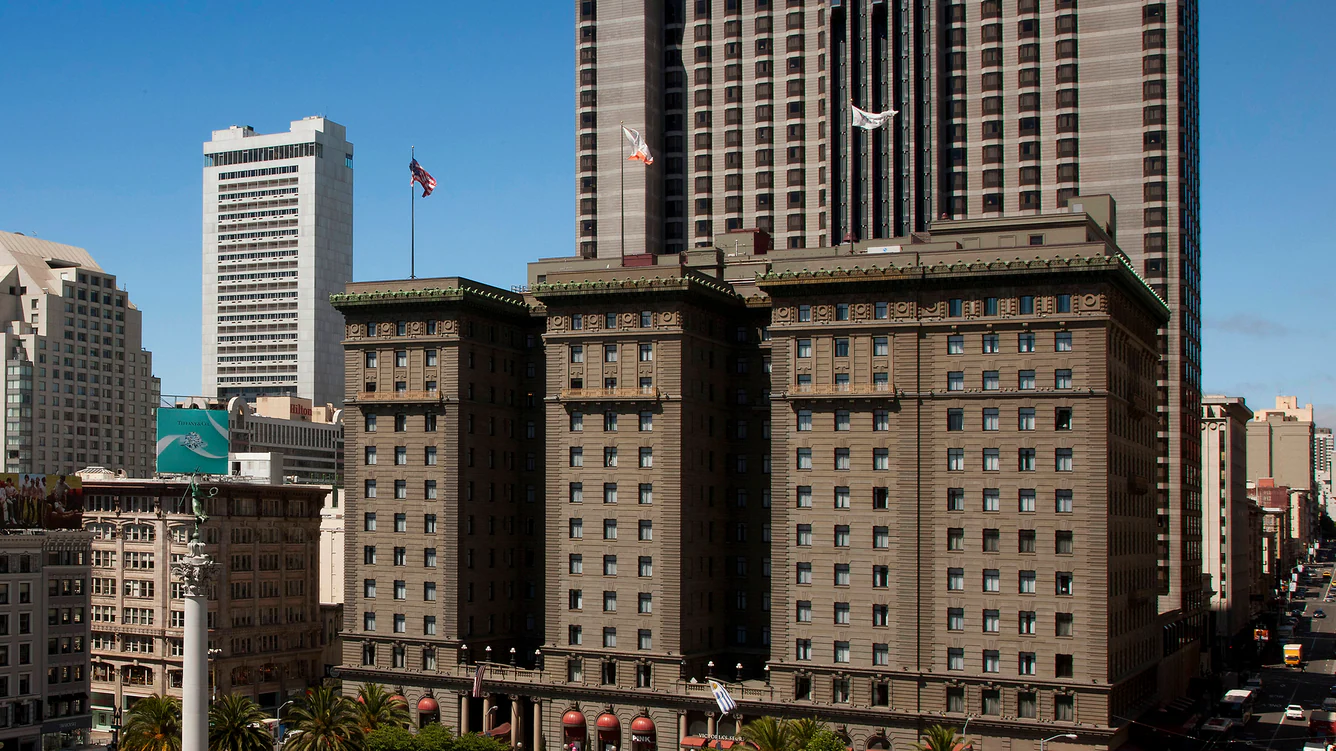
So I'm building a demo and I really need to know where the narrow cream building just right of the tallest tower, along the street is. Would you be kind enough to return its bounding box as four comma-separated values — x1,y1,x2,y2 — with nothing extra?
1201,394,1265,655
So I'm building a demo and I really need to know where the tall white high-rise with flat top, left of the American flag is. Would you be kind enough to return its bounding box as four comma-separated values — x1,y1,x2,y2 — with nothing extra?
203,116,353,405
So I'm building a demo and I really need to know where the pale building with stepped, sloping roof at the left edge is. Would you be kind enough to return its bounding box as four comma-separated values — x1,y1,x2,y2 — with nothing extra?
0,233,160,477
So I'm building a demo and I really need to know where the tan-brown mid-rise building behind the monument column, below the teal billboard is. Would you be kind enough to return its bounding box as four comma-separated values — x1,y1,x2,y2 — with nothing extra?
84,474,330,732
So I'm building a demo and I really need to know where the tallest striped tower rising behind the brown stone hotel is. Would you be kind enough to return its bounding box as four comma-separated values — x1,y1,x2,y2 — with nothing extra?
576,0,1205,678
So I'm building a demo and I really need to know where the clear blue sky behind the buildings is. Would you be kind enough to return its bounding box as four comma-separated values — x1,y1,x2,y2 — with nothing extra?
0,0,1336,425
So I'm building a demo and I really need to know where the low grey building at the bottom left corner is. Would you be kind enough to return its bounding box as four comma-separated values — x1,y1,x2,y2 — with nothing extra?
0,529,92,751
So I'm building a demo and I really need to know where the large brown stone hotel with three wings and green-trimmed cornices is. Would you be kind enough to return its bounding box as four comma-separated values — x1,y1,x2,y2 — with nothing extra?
334,198,1168,750
